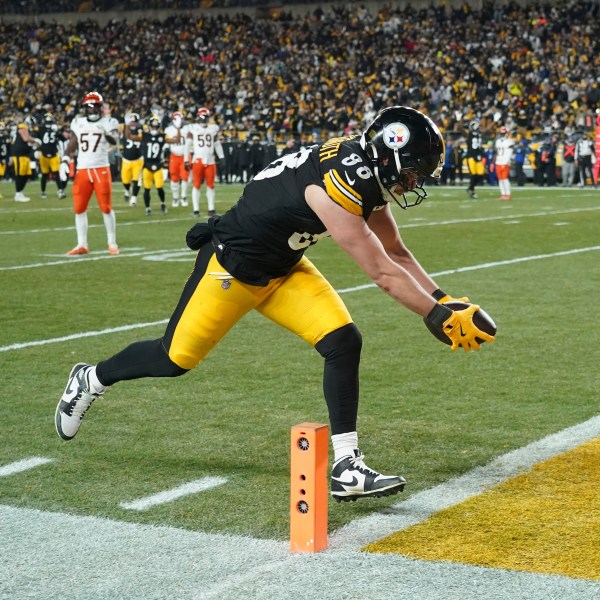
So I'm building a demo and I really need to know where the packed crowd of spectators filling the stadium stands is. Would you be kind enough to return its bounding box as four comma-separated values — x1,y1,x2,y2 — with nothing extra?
0,0,600,185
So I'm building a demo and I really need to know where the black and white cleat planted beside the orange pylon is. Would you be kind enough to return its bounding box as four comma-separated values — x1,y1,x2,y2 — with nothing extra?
331,448,406,502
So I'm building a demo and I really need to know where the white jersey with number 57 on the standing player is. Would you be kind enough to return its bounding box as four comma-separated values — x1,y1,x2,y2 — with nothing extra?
71,116,119,169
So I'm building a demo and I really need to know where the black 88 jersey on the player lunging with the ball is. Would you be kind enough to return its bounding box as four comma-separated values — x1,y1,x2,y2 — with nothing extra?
210,136,385,285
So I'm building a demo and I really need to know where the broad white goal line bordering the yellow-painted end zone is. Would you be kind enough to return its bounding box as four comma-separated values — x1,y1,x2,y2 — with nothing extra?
330,415,600,548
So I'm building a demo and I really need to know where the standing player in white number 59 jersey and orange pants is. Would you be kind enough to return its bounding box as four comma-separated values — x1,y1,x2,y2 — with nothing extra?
186,107,224,217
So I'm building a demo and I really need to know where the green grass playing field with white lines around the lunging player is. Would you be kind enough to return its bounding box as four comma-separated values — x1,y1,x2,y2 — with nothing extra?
0,182,600,540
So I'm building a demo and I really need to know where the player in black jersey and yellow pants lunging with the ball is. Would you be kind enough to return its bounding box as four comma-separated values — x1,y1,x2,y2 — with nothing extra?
55,106,494,501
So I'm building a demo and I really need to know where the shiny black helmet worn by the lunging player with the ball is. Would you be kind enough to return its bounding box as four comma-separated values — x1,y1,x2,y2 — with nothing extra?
361,106,445,208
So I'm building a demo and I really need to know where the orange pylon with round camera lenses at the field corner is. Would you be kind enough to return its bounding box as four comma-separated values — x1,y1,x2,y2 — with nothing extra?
290,423,329,552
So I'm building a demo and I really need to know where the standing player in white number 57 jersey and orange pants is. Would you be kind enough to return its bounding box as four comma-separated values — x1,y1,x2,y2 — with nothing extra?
60,92,119,256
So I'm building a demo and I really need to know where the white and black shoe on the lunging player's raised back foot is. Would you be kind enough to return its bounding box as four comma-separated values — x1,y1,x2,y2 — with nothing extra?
54,363,102,440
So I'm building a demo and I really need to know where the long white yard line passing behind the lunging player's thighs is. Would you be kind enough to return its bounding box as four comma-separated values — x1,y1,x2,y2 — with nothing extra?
0,246,600,352
